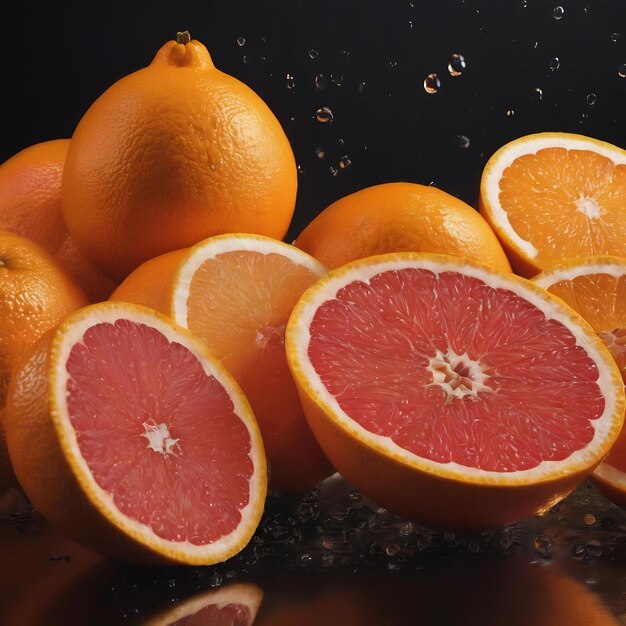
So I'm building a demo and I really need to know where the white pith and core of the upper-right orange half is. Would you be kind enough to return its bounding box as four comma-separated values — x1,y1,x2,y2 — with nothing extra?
482,134,626,258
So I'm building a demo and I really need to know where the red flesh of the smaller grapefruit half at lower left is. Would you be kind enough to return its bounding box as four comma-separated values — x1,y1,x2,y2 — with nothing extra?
59,319,254,546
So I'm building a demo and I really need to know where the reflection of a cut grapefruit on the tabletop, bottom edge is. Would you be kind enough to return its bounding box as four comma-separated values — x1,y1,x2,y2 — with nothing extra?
142,583,263,626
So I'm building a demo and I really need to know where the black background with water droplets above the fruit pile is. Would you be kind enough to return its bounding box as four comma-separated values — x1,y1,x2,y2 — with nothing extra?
0,0,626,235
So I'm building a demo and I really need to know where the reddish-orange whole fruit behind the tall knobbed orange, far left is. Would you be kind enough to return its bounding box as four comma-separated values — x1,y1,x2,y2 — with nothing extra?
0,139,115,302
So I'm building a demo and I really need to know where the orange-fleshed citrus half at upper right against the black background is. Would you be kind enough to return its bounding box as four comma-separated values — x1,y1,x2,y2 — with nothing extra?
480,133,626,276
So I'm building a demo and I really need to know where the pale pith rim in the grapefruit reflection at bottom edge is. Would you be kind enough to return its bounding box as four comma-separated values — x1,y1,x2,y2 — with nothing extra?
143,583,263,626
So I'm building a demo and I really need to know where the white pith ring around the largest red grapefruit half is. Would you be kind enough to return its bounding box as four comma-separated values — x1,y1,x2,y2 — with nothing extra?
287,255,621,485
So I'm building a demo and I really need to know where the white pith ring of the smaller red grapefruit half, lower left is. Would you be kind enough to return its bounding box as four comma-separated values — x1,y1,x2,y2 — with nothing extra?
53,303,265,561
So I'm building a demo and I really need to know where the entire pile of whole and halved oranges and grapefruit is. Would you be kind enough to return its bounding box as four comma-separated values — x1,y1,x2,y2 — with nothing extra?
0,33,626,564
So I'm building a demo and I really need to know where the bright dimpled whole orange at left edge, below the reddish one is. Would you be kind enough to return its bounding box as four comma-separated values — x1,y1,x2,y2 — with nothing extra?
0,231,88,486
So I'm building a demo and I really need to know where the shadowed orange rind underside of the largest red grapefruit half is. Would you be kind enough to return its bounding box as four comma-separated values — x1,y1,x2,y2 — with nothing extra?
300,393,591,531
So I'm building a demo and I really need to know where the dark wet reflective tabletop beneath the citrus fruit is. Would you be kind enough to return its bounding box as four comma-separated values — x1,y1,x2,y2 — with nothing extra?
0,478,626,626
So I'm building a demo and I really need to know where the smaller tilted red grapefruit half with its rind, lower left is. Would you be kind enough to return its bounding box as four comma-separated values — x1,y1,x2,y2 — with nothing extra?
7,303,266,564
